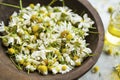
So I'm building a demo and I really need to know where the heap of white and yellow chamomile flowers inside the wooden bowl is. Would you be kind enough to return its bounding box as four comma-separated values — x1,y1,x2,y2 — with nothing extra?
0,3,94,75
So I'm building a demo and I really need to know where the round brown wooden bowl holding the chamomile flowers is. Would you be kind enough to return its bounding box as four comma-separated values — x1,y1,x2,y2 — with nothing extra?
0,0,104,80
